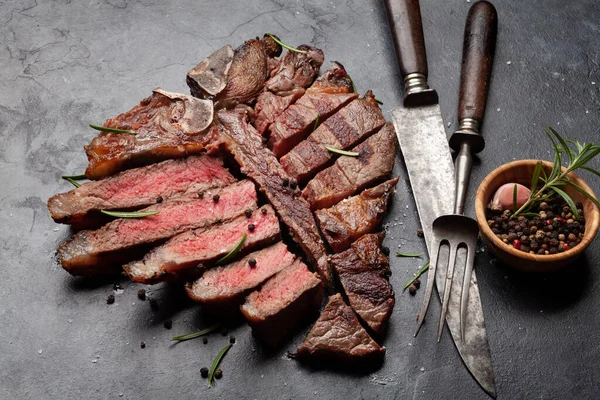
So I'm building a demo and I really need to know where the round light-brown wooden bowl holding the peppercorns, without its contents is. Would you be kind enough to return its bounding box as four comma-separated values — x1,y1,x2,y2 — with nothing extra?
475,160,600,272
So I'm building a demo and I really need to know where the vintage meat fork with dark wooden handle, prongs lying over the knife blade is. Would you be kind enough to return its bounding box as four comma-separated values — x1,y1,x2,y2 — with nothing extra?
415,1,497,342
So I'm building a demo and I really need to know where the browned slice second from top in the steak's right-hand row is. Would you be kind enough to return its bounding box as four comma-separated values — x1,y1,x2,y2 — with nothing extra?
269,63,358,158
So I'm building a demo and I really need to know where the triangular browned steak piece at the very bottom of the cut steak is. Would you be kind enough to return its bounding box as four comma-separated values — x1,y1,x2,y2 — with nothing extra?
296,293,385,368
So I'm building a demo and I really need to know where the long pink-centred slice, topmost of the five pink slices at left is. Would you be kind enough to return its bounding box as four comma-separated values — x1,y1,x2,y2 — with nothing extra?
48,155,235,229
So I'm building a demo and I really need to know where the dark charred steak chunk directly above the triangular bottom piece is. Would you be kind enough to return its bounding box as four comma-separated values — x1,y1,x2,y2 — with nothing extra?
331,234,396,335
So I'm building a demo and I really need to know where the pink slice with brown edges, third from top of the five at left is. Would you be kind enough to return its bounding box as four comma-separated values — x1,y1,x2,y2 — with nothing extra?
124,205,281,284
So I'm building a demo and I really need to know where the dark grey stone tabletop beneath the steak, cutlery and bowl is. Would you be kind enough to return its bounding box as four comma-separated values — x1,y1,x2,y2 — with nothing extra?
0,0,600,399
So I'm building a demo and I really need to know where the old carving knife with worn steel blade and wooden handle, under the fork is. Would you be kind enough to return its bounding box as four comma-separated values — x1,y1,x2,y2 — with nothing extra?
385,0,496,398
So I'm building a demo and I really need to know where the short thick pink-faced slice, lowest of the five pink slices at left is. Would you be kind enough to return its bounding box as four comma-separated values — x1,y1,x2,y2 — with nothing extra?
240,259,323,346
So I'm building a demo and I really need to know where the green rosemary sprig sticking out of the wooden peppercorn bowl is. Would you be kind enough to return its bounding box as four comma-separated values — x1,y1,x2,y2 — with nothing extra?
512,127,600,218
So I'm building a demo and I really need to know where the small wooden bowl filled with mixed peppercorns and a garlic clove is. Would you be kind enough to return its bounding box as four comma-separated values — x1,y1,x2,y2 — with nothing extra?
475,160,600,272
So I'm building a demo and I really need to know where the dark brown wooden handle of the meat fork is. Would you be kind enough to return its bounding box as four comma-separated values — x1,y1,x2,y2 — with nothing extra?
458,1,498,125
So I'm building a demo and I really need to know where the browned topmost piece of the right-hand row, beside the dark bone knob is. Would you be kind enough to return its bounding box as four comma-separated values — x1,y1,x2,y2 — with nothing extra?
254,45,324,135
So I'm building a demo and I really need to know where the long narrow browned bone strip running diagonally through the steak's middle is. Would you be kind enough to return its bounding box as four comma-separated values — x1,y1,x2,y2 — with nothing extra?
213,111,331,286
